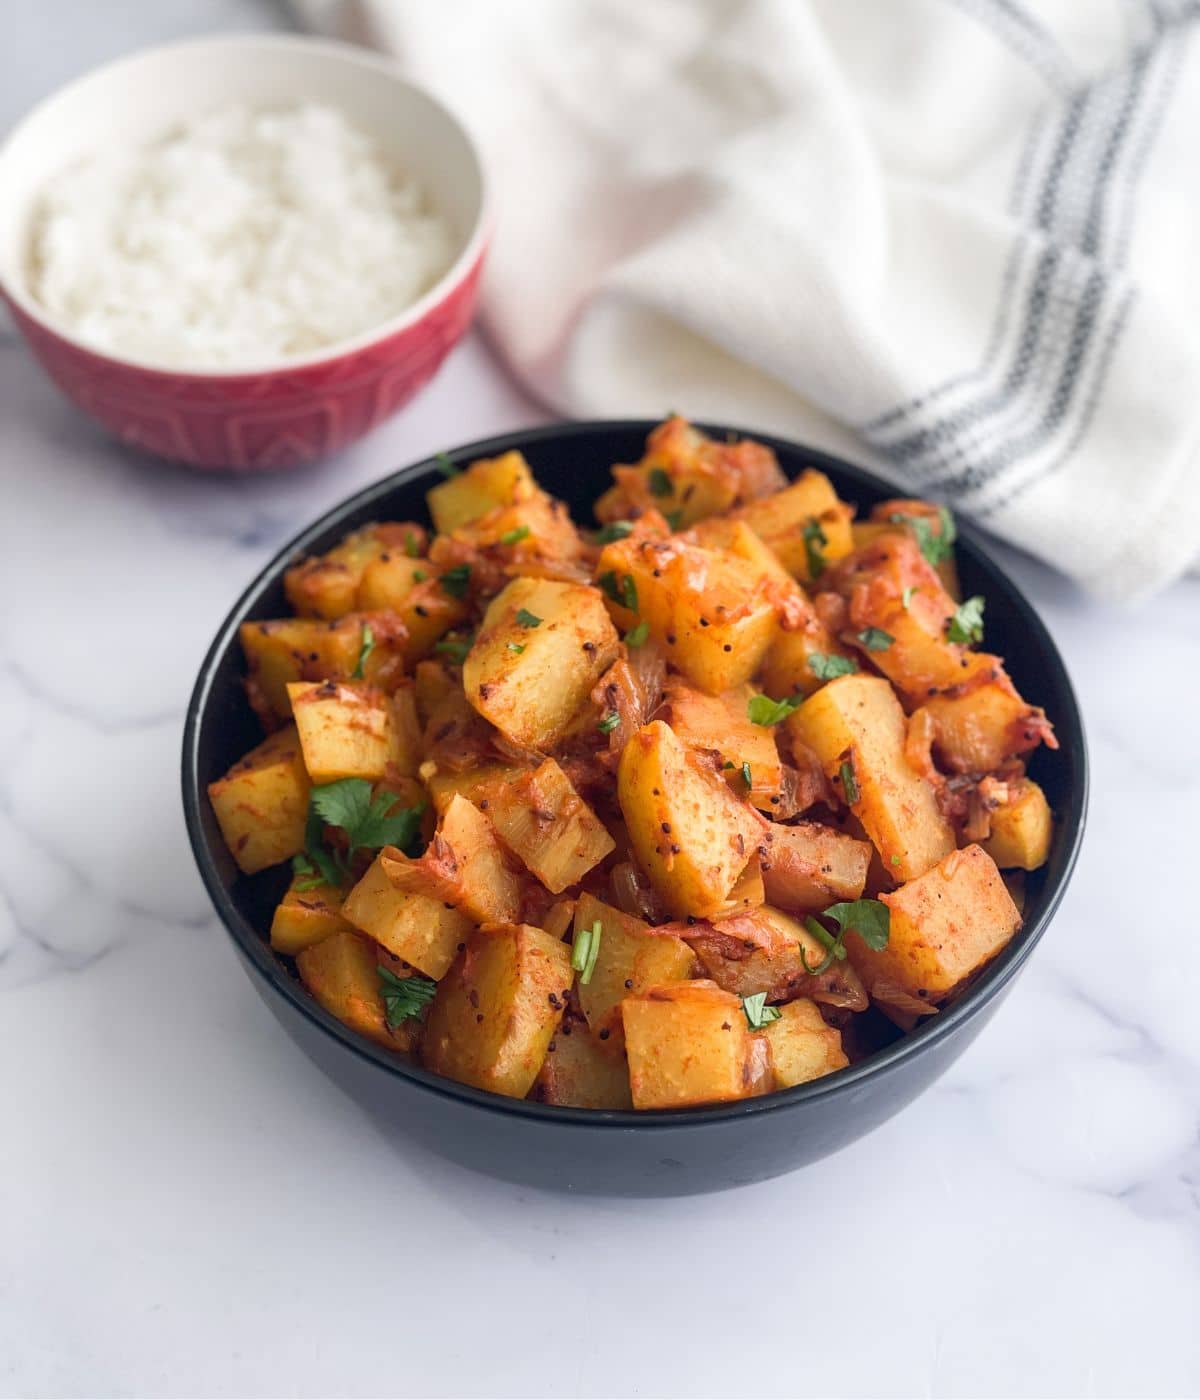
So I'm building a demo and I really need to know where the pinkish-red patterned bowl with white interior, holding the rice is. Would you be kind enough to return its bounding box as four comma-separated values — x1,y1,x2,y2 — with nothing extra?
0,35,487,468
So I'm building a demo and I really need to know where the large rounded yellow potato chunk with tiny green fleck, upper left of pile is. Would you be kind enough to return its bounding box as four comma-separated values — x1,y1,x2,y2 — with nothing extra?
462,578,619,750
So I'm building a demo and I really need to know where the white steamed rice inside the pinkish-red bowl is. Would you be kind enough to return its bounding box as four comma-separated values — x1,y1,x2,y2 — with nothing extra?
31,104,454,370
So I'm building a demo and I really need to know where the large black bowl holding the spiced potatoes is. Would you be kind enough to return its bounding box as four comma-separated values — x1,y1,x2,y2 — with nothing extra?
183,421,1088,1196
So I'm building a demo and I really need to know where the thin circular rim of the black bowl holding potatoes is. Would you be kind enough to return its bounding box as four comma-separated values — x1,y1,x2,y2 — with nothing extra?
182,419,1088,1133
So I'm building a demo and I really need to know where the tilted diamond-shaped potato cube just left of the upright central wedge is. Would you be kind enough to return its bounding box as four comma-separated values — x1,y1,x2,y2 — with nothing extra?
487,759,615,895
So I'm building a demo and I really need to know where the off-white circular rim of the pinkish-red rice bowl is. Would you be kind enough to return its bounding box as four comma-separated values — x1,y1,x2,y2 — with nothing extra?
0,34,494,382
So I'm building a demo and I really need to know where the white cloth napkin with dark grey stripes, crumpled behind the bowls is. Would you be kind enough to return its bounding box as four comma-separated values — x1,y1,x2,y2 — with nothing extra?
298,0,1200,599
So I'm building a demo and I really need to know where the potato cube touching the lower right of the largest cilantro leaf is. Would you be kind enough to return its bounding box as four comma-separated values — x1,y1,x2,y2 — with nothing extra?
342,847,475,981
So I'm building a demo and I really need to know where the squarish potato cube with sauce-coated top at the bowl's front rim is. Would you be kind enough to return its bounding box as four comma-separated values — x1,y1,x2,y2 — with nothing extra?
620,980,756,1109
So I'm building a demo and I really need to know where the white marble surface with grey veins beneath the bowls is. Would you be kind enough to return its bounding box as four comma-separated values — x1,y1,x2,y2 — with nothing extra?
0,4,1200,1396
